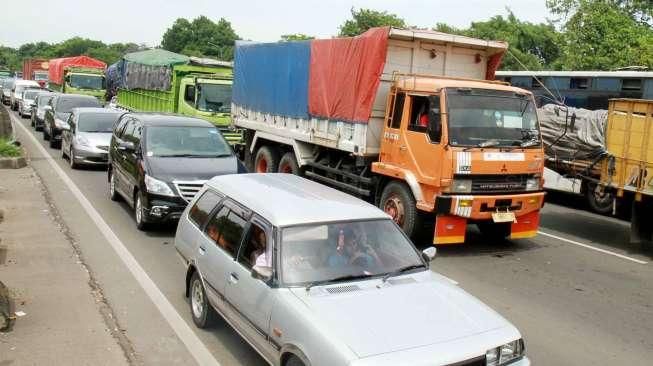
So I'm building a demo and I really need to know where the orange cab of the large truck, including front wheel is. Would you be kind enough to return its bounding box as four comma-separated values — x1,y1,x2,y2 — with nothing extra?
372,75,544,244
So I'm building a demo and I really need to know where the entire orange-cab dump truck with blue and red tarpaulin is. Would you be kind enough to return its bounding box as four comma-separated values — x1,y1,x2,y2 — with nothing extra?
231,28,544,244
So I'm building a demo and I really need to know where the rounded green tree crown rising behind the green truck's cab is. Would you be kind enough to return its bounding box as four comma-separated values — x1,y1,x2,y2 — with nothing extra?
161,15,240,61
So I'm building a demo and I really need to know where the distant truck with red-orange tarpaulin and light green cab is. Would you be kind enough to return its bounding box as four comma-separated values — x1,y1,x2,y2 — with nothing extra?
48,56,107,102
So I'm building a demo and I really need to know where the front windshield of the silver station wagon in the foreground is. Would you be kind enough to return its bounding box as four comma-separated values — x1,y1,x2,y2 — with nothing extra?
280,220,423,286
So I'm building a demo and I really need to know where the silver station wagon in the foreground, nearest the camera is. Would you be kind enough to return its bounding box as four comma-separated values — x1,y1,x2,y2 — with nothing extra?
175,174,530,366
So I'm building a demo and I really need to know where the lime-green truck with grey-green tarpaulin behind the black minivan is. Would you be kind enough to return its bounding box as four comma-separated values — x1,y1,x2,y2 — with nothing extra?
107,49,242,144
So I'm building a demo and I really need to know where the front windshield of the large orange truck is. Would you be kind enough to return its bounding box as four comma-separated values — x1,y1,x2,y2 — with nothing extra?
446,88,540,147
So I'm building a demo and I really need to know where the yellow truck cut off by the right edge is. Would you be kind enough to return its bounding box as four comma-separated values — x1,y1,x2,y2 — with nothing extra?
601,99,653,246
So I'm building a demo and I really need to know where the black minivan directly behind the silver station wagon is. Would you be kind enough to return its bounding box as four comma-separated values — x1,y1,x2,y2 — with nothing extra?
108,113,246,230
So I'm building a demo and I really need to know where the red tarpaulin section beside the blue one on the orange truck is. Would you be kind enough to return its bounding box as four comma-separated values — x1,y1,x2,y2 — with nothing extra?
308,27,390,123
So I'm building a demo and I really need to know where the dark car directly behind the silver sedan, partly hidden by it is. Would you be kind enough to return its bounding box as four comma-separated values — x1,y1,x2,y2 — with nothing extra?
43,94,101,148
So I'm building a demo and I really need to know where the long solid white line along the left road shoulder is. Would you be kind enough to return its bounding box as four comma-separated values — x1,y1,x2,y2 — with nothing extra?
10,110,220,366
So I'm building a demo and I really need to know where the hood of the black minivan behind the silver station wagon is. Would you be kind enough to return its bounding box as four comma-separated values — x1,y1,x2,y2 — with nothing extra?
147,156,238,182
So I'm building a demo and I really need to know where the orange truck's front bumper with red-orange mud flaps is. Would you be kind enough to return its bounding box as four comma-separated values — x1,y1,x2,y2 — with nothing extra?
433,192,545,244
